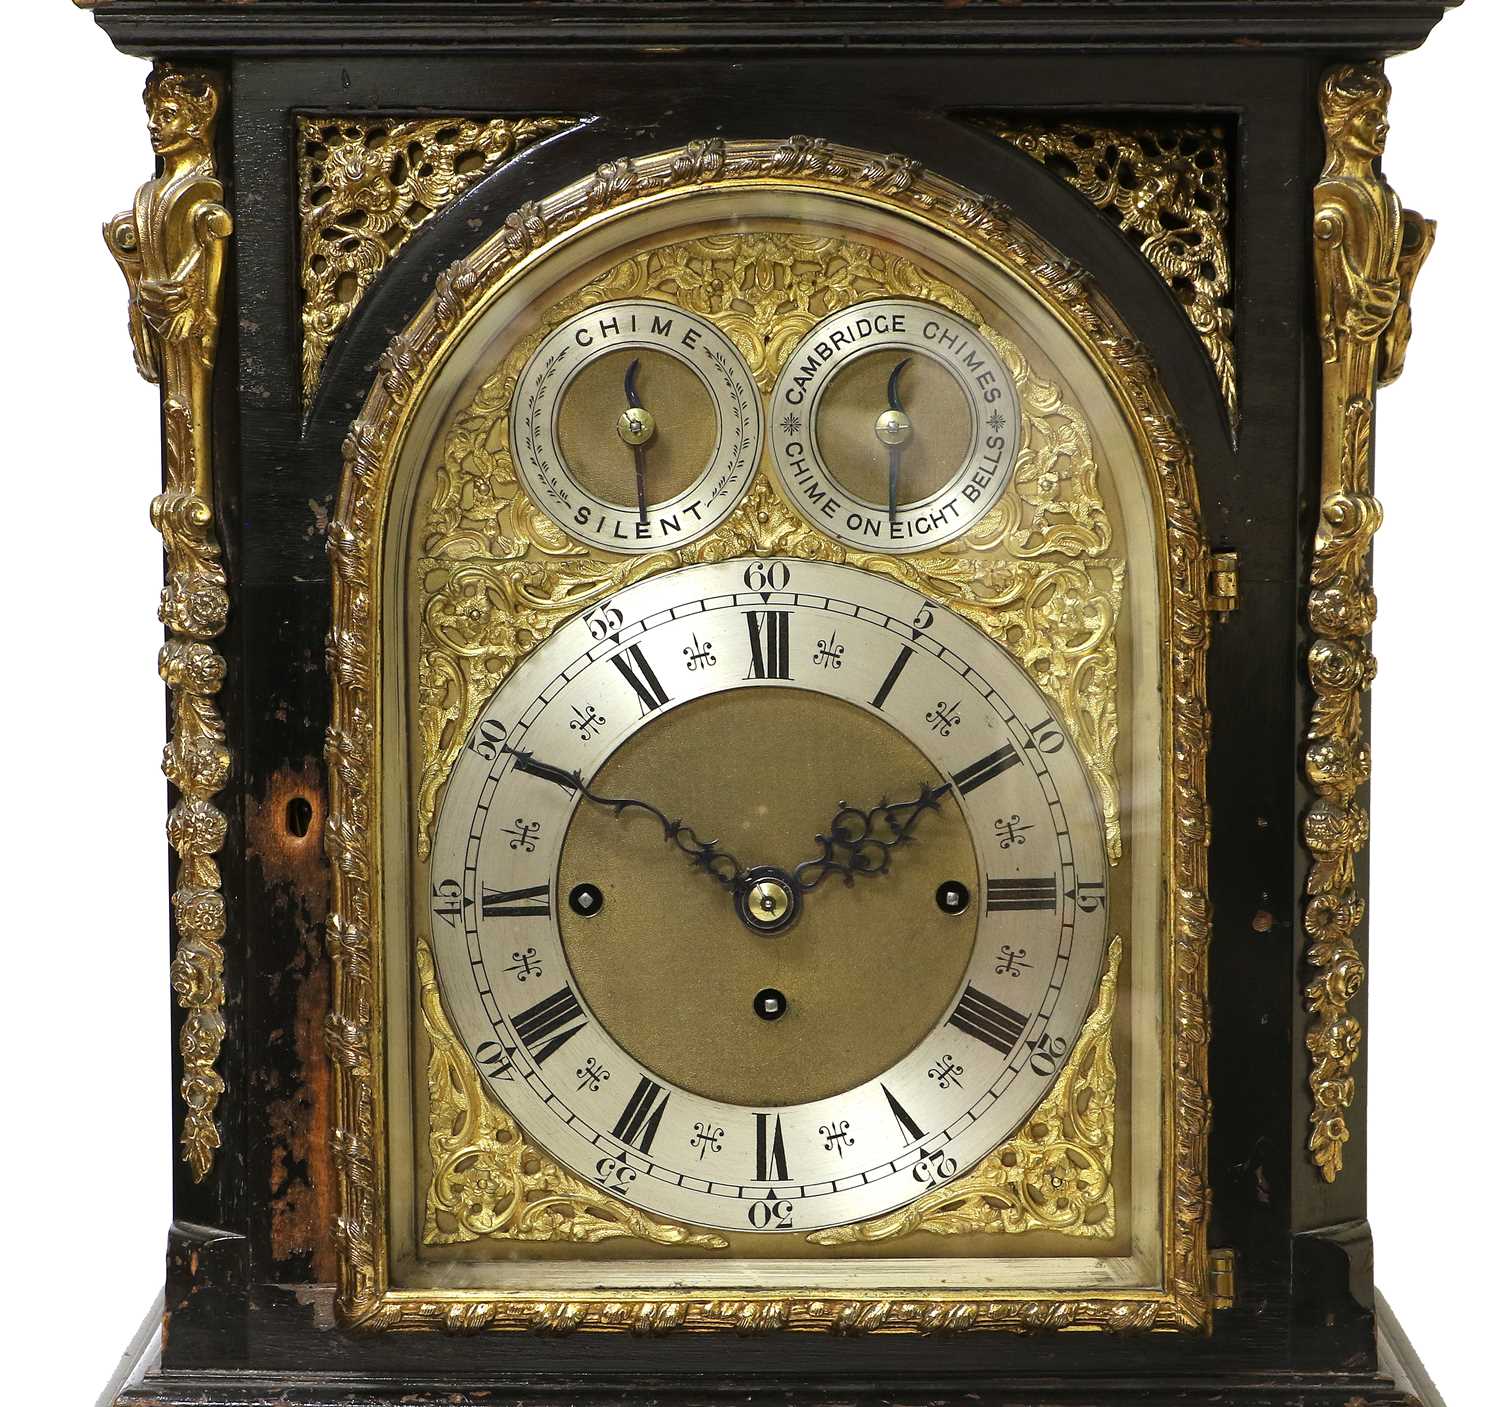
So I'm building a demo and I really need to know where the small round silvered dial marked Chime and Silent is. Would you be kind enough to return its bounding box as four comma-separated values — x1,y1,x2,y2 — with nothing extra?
510,299,762,554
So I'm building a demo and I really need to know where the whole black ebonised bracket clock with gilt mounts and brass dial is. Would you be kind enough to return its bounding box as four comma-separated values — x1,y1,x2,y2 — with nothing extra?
79,0,1464,1407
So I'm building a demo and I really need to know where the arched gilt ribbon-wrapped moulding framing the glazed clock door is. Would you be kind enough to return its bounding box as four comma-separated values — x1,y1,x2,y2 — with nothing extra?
327,137,1211,1332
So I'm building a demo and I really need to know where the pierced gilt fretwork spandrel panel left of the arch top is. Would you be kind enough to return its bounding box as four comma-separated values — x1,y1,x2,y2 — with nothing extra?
297,114,578,405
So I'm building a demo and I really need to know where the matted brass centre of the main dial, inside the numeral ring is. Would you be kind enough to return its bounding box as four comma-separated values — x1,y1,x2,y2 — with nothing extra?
558,687,977,1106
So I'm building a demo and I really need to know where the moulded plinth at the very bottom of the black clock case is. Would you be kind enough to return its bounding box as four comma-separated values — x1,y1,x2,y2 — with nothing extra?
99,1299,1443,1407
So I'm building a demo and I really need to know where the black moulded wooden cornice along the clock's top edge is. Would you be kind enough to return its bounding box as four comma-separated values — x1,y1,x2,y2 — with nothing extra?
93,0,1458,57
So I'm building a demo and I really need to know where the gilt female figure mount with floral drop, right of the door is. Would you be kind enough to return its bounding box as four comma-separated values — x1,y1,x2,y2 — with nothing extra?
1302,65,1437,1182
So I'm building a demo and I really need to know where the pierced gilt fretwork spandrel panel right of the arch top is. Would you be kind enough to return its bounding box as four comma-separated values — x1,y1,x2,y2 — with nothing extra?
972,116,1239,431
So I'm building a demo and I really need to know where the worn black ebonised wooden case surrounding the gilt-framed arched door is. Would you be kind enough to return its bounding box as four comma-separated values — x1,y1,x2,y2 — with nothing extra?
82,0,1443,1407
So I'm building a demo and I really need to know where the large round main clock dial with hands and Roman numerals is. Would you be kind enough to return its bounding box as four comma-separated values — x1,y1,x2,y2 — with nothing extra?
431,558,1107,1232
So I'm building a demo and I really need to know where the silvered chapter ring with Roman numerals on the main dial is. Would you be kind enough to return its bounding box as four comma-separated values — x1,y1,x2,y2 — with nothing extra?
431,558,1107,1232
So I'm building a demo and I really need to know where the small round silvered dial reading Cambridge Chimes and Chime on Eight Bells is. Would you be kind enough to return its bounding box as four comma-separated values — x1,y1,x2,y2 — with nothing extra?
771,299,1022,552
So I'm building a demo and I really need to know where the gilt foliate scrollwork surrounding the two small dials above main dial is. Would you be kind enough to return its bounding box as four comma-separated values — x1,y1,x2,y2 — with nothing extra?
417,233,1125,861
